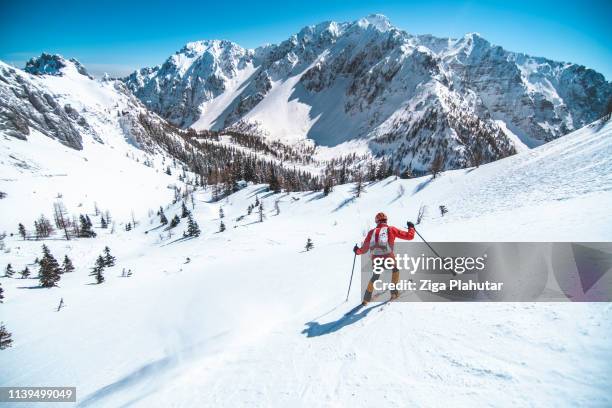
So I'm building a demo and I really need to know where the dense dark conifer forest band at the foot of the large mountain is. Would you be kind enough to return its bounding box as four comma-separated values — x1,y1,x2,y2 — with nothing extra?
140,115,402,199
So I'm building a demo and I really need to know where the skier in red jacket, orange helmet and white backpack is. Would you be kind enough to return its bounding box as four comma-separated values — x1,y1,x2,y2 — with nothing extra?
353,212,414,306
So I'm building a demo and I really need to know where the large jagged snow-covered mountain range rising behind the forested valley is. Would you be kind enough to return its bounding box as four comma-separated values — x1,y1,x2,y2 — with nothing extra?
125,15,612,170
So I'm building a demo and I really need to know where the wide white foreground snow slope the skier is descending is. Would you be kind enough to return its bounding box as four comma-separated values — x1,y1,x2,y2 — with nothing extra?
0,118,612,407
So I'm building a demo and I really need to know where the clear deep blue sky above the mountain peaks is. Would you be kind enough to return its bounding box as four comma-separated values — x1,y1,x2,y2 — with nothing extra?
0,0,612,80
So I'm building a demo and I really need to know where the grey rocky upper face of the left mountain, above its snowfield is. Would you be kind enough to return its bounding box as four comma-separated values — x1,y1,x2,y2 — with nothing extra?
0,54,182,152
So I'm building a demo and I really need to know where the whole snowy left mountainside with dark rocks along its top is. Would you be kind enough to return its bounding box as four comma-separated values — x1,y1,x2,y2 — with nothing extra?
0,54,194,231
